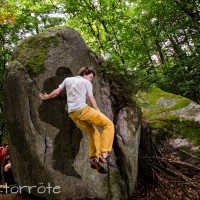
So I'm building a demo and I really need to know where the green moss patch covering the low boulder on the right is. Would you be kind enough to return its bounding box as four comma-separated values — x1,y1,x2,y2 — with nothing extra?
141,87,200,146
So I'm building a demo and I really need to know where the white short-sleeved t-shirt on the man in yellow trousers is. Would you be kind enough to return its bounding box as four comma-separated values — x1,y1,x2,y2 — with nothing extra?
59,76,93,113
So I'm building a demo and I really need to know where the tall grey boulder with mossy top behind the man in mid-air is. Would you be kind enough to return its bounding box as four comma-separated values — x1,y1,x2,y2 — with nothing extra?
4,27,141,200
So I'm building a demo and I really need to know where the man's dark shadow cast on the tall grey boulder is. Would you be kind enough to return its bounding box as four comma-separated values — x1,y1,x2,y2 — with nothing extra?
39,67,83,178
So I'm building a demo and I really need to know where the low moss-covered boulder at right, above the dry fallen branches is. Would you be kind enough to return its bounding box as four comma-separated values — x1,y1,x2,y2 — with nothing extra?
138,87,200,164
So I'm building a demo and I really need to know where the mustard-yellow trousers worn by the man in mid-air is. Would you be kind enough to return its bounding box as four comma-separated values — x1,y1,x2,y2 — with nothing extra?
69,106,114,158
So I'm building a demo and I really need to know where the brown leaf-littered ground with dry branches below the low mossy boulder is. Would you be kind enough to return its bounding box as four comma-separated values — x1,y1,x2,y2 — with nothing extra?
131,145,200,200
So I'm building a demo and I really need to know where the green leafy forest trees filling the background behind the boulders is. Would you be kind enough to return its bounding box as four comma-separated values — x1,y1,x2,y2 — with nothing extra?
0,0,200,142
